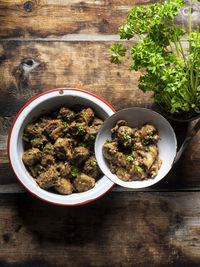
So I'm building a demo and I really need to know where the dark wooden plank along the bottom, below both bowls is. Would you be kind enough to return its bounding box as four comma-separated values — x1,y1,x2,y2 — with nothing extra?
0,192,200,267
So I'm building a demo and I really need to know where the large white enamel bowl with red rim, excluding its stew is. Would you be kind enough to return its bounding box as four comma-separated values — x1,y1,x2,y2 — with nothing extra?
8,88,115,206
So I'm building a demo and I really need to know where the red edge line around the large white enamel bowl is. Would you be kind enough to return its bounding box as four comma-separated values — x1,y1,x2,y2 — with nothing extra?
7,88,116,206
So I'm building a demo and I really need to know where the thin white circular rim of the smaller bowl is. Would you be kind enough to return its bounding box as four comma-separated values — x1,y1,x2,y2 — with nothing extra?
95,106,177,190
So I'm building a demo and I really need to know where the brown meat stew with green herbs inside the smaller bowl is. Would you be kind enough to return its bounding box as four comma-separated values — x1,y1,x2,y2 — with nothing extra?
102,120,162,182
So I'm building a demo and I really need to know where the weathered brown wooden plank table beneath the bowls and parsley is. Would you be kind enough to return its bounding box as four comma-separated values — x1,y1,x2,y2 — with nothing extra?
0,0,200,267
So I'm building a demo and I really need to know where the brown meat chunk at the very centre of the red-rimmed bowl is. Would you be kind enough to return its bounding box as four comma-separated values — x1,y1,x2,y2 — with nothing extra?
54,138,73,160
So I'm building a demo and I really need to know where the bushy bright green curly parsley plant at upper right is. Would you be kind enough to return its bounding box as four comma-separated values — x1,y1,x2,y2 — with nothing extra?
109,0,200,119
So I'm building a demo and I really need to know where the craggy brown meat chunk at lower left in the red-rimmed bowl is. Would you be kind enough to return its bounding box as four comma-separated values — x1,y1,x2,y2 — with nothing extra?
36,166,59,189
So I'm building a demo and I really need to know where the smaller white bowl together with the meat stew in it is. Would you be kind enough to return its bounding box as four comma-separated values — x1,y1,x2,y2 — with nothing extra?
95,107,177,188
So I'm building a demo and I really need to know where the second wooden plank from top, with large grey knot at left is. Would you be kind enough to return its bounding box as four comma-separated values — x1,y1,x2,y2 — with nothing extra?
0,41,153,116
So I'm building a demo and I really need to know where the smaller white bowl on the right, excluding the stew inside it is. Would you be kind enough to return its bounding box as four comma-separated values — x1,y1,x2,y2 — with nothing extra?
95,107,177,189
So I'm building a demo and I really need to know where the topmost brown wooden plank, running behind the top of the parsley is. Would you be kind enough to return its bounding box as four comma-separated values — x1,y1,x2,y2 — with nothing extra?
0,0,200,39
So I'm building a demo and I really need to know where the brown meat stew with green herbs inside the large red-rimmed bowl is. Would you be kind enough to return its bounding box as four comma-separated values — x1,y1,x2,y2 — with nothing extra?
22,106,103,195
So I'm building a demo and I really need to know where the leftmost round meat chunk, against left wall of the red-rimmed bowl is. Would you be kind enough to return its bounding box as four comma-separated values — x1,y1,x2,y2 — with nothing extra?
22,148,42,166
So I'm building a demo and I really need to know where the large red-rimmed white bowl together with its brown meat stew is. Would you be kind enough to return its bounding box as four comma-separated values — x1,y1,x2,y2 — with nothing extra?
8,88,115,206
